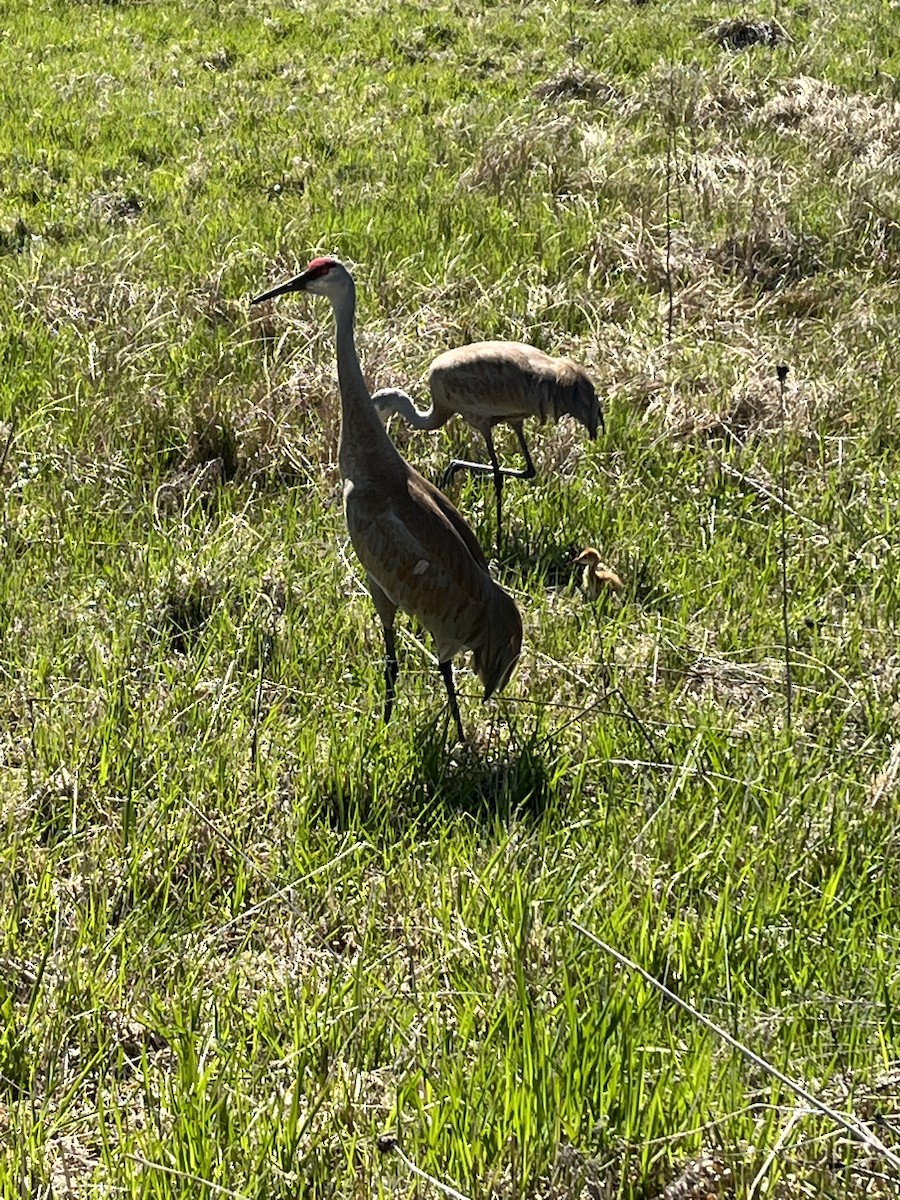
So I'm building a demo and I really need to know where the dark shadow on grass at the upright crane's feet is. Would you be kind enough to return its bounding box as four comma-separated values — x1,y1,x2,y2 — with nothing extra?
310,716,553,835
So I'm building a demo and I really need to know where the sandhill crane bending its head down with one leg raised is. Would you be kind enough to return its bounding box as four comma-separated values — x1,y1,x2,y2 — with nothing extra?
372,342,604,554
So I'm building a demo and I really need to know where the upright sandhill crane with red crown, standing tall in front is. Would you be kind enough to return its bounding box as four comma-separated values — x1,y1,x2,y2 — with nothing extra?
251,258,522,742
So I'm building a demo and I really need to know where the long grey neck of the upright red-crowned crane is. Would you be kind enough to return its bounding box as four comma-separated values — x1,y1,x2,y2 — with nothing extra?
332,281,400,479
